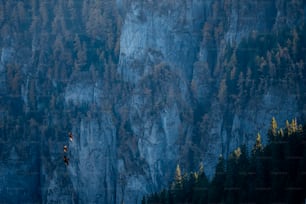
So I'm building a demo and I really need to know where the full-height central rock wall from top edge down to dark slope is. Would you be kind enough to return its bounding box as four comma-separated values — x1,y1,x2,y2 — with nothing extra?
118,1,206,203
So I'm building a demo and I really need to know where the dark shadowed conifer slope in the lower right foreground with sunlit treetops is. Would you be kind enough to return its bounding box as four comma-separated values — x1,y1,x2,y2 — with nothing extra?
143,119,306,204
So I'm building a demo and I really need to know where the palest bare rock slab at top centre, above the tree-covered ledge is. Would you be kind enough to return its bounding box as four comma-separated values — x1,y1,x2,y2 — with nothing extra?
118,1,205,83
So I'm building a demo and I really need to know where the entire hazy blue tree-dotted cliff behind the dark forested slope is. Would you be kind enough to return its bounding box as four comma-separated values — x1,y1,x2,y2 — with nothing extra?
0,0,306,203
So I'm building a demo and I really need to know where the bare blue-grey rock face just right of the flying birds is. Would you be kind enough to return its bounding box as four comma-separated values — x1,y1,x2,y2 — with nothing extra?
68,116,116,203
